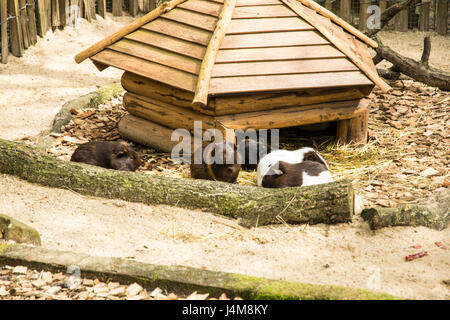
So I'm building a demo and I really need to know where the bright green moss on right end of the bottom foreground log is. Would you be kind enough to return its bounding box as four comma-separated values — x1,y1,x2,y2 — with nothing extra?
231,274,398,300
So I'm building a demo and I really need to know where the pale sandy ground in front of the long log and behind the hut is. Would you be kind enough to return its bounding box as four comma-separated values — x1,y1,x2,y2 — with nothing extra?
0,17,450,299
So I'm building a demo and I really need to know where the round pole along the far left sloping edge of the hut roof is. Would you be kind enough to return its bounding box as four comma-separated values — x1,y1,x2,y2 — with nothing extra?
75,0,186,63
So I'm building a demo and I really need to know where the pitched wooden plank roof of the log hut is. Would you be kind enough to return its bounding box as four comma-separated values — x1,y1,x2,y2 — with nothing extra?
76,0,389,103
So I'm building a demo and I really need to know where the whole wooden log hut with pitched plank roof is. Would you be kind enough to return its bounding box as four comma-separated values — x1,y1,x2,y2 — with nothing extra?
75,0,389,150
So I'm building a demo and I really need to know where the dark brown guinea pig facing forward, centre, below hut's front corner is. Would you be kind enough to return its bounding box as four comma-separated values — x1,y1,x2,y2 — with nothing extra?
190,141,241,183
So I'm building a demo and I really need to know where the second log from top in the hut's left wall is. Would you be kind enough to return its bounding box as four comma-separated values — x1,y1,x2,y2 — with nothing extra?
123,92,215,131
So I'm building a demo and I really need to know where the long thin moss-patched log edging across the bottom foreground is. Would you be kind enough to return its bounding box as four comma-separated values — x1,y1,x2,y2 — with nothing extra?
0,242,402,300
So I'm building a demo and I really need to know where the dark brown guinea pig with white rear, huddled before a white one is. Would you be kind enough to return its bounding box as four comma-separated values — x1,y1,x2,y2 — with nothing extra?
261,160,333,188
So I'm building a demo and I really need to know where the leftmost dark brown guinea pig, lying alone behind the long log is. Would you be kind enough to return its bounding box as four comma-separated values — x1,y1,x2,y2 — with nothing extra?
70,141,142,171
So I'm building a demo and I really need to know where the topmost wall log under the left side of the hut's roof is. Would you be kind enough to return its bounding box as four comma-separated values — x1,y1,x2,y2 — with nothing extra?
121,72,194,108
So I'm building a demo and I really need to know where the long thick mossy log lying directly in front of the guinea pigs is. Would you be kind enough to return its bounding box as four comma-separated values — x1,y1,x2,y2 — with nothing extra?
0,139,354,227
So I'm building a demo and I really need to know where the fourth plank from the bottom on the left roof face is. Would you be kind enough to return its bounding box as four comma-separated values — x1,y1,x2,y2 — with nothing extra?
142,18,212,46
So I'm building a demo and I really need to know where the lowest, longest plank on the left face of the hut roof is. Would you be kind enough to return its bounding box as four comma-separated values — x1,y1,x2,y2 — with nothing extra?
92,49,197,92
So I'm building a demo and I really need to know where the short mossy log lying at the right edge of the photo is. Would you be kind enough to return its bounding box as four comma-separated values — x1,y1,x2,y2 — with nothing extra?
361,189,450,230
